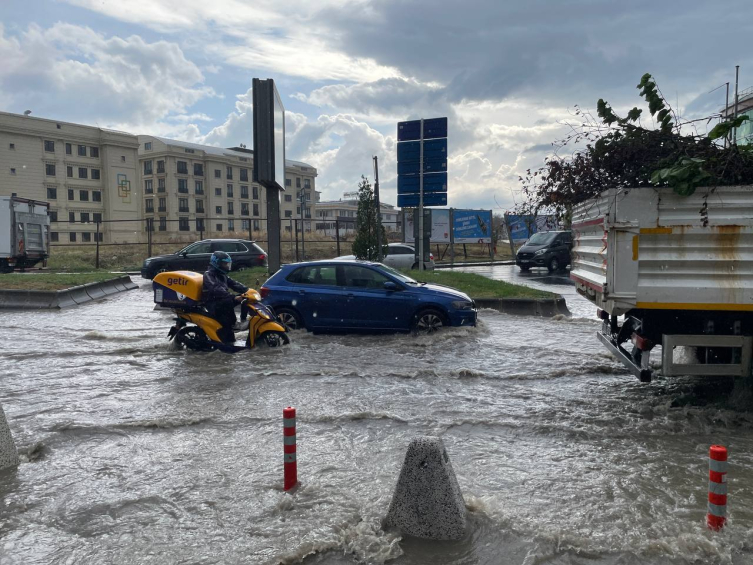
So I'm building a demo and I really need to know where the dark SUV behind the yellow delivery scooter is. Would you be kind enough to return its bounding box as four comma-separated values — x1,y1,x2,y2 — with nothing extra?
141,239,267,279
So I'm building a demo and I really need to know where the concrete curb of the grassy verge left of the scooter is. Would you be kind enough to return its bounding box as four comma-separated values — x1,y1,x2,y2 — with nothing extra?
0,275,138,310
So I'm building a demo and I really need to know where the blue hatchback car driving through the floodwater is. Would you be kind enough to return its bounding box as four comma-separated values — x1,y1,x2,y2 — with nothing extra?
260,261,477,333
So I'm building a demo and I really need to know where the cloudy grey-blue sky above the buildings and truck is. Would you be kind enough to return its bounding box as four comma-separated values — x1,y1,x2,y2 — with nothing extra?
0,0,753,210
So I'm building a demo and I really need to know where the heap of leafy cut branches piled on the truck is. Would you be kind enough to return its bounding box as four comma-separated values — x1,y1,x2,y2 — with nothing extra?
516,73,753,219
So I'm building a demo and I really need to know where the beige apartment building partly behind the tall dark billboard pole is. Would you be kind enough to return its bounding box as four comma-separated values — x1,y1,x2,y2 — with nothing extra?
138,135,316,238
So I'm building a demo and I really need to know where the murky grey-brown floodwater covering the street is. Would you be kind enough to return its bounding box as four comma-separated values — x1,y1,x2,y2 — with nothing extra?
0,279,753,565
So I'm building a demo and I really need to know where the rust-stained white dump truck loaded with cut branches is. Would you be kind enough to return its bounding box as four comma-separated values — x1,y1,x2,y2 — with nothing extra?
570,186,753,382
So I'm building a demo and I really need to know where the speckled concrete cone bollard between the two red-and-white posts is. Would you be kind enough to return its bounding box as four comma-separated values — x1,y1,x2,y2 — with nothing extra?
384,437,466,540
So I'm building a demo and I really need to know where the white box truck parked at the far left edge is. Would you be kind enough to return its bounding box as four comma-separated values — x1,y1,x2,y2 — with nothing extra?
0,196,50,273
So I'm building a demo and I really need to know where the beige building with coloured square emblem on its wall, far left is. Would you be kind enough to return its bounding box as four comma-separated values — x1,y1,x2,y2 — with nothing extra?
0,112,143,244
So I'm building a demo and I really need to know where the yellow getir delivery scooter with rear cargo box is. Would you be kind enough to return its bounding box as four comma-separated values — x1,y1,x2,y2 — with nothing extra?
152,271,290,353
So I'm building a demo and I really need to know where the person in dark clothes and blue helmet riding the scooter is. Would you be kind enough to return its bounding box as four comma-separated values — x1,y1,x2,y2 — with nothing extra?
201,251,248,343
